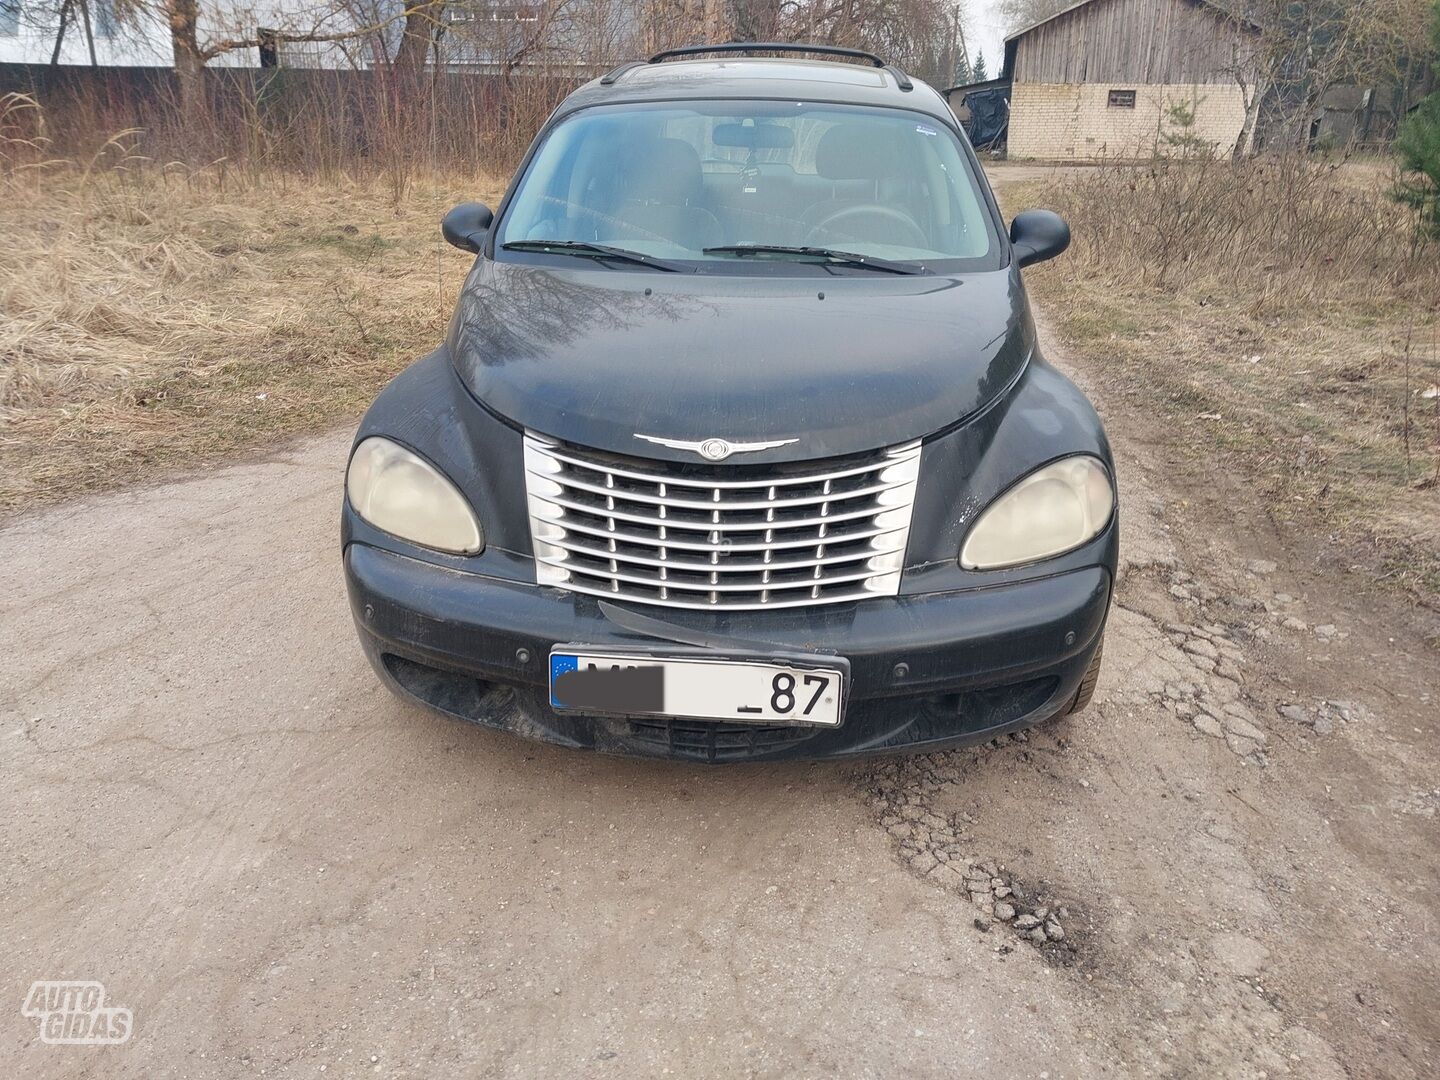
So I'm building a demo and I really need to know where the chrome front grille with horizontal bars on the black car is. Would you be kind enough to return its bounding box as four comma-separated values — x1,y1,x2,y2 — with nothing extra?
526,435,920,611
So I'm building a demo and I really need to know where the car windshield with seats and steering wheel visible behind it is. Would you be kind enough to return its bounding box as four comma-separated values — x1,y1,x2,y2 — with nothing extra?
497,101,998,271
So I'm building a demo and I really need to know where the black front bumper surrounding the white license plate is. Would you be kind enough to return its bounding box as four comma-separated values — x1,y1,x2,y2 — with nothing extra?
344,543,1112,762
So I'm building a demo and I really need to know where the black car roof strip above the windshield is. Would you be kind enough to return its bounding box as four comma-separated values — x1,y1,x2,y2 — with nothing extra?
557,56,956,127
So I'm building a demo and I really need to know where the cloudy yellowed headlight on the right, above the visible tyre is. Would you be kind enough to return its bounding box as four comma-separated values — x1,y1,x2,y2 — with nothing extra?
960,455,1115,570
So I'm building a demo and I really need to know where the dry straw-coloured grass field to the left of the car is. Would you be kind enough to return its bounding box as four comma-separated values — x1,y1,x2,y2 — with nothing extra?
0,162,500,511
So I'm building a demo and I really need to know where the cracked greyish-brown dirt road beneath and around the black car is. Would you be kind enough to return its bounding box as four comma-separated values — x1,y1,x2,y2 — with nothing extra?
0,308,1440,1080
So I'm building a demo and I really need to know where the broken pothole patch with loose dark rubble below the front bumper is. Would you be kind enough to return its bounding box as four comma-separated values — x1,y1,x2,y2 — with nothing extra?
864,748,1086,965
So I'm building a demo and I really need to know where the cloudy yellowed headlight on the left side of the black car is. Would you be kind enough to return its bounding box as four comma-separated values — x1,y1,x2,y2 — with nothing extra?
346,436,485,554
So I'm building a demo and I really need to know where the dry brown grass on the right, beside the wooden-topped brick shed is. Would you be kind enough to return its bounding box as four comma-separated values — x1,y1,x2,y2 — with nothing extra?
1009,160,1440,600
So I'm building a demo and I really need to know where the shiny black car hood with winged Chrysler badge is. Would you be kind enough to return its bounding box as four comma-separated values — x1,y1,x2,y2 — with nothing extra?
448,259,1034,462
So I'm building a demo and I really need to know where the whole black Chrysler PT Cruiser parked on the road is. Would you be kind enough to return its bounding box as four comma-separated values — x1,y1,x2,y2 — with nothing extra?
343,45,1117,762
